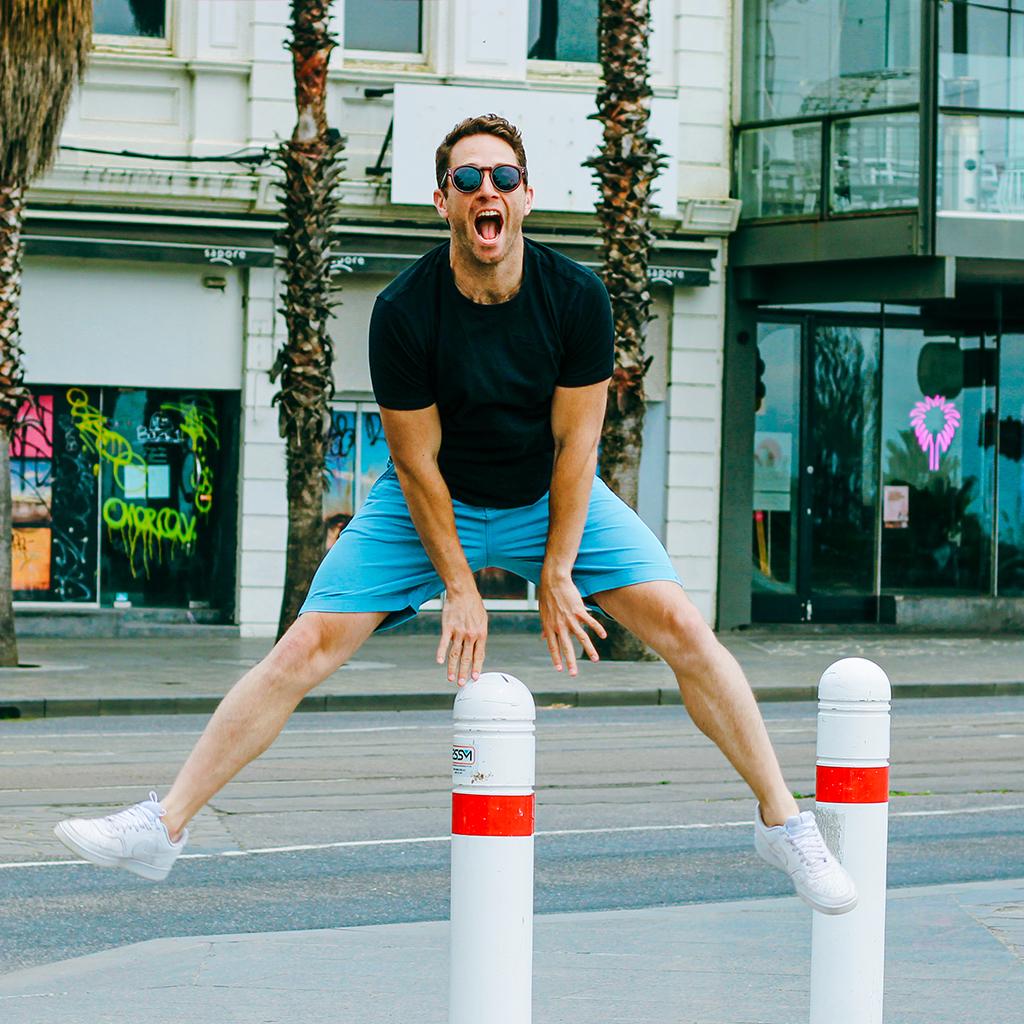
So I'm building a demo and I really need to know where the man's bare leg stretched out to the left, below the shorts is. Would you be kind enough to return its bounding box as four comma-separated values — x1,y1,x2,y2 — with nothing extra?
161,611,384,842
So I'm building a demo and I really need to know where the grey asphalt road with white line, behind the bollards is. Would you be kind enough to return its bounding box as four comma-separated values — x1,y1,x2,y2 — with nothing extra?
0,697,1024,973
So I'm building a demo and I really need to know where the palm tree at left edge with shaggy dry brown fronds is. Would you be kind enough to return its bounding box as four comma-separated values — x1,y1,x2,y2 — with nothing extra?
0,0,92,666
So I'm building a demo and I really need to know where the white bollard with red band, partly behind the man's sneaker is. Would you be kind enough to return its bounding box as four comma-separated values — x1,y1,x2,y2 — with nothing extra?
811,657,892,1024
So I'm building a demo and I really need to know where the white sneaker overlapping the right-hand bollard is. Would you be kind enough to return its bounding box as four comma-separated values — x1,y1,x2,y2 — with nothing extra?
754,807,857,913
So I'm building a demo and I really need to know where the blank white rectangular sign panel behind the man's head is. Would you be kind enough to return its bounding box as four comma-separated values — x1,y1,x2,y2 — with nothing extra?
391,83,679,213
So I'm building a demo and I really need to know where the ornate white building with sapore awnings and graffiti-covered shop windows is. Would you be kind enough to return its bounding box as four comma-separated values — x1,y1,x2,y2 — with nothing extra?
12,0,737,636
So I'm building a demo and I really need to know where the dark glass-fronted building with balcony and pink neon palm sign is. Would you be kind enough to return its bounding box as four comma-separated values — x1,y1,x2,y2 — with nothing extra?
719,0,1024,628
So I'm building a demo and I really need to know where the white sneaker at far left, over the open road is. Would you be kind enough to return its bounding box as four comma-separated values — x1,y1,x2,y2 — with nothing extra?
53,793,188,882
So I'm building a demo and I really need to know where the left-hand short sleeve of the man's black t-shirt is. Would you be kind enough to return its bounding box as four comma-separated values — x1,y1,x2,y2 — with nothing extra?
370,296,435,410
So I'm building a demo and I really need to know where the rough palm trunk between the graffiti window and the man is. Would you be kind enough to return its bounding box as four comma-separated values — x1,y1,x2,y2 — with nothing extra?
270,0,345,638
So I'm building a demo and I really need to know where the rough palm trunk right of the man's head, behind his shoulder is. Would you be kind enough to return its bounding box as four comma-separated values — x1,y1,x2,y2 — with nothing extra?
586,0,664,660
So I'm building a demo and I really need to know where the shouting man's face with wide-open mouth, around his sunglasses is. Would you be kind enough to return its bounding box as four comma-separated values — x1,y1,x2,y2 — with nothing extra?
434,135,534,265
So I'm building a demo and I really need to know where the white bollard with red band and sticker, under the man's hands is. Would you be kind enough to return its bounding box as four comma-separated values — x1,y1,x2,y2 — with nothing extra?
449,672,537,1024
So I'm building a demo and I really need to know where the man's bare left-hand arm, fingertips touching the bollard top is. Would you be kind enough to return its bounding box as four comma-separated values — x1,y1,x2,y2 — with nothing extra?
381,406,487,686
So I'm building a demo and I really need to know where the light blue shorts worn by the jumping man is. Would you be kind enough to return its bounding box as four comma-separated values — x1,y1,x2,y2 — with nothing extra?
299,464,679,630
